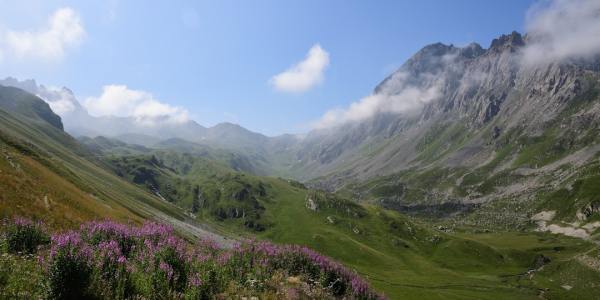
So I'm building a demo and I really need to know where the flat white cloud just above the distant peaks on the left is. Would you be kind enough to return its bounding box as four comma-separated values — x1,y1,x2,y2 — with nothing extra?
84,85,189,126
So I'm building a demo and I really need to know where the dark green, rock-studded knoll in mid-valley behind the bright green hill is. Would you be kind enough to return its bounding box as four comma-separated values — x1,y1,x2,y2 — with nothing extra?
98,150,273,231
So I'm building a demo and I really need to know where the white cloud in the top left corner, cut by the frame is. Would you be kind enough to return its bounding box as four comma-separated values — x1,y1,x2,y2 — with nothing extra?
0,7,85,61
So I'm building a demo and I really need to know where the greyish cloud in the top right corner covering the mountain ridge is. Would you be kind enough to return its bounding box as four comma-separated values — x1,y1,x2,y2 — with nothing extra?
523,0,600,64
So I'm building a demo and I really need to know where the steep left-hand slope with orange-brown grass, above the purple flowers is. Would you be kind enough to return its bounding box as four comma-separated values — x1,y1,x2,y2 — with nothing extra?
0,86,225,241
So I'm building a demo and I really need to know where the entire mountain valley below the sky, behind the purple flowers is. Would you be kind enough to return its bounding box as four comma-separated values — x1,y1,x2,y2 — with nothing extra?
0,32,600,299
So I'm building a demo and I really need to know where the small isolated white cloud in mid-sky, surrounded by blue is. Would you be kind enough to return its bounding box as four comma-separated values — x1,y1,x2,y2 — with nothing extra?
269,44,329,93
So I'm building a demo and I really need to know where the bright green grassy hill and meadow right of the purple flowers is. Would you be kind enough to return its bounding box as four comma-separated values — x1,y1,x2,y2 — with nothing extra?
251,180,599,299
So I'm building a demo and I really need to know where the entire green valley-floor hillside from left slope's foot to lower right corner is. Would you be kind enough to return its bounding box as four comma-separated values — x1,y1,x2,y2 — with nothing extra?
94,152,599,299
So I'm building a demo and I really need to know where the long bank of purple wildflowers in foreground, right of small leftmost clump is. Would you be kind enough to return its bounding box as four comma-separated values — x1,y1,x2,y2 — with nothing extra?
3,219,383,299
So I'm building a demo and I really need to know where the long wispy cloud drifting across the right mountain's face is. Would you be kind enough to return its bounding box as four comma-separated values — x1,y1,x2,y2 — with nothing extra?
313,73,441,129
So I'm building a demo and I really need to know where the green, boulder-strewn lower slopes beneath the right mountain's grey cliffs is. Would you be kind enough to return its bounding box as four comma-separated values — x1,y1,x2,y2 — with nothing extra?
340,87,600,229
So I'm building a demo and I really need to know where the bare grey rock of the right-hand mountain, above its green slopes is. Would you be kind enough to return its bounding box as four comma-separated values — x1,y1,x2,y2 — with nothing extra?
284,32,600,189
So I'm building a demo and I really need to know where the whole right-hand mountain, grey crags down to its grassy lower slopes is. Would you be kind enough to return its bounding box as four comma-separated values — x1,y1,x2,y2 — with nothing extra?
274,32,600,235
